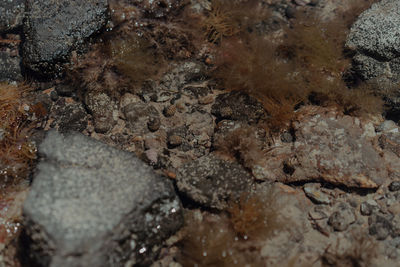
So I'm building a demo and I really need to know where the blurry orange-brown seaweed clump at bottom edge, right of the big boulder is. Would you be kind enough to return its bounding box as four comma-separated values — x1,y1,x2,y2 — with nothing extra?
178,189,289,266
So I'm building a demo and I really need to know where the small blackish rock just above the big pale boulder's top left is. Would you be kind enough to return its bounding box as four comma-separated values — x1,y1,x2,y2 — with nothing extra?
54,99,88,132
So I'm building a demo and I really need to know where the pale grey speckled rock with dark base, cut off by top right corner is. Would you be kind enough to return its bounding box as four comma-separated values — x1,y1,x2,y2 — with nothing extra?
346,0,400,120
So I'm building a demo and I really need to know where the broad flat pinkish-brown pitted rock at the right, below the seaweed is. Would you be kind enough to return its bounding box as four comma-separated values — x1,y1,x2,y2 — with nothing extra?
252,107,400,188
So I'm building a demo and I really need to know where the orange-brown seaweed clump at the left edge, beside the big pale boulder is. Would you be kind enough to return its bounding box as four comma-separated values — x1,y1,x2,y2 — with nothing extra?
0,83,36,186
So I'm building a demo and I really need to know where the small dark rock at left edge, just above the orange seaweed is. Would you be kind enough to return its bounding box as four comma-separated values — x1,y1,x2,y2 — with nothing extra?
0,51,23,81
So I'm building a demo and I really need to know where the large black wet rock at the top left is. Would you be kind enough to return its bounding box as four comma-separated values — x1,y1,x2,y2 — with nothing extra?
23,0,108,75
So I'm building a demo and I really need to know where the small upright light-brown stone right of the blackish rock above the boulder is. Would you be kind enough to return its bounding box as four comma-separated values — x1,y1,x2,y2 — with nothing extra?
85,93,117,133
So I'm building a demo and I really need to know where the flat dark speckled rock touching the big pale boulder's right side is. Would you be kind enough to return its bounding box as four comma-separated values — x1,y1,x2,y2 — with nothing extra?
176,154,252,209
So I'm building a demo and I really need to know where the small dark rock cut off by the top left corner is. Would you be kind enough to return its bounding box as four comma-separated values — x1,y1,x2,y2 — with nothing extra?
0,0,25,33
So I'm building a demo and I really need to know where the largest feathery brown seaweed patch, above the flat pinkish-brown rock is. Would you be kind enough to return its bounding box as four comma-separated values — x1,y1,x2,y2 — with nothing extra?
208,0,383,133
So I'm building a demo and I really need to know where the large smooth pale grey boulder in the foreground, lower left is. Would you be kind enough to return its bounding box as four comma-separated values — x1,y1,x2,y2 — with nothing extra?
23,131,183,266
